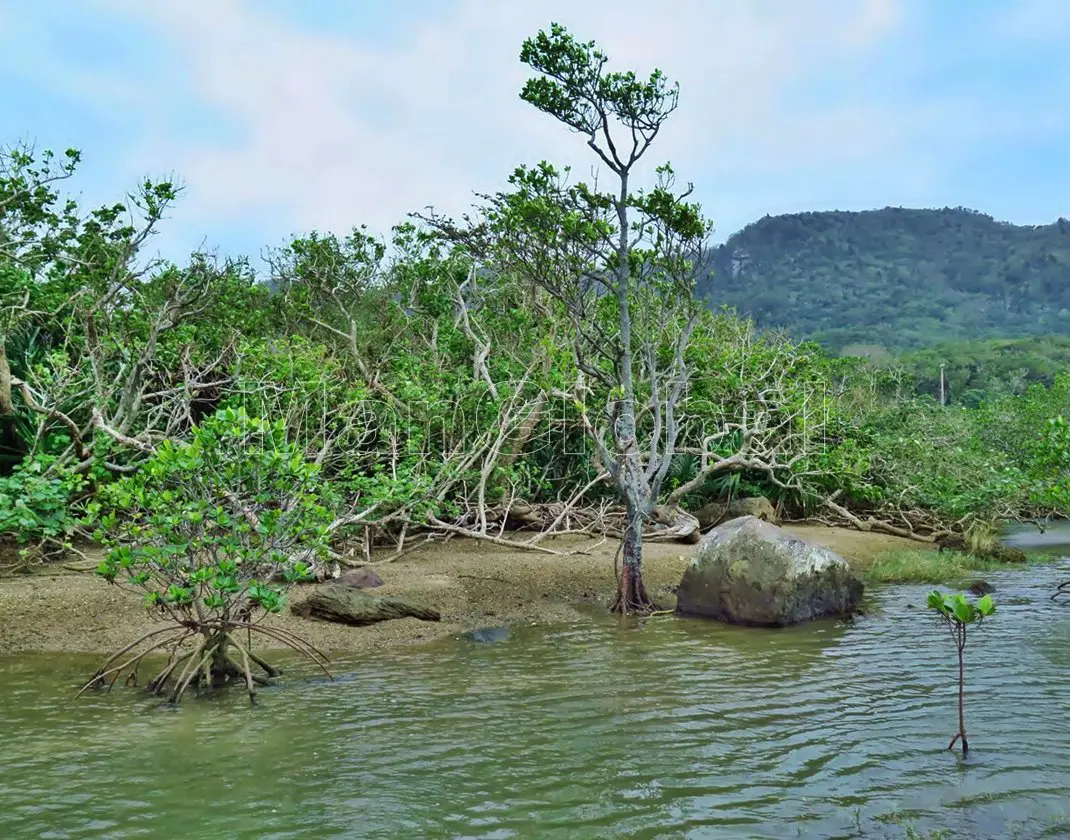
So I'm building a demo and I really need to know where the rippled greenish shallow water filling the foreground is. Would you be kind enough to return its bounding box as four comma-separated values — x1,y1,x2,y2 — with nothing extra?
0,562,1070,840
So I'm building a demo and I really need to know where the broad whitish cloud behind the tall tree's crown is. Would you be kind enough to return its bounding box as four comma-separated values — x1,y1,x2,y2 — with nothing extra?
94,0,904,246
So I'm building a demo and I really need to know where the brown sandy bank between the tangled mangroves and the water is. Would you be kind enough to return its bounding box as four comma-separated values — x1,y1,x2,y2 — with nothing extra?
0,524,918,655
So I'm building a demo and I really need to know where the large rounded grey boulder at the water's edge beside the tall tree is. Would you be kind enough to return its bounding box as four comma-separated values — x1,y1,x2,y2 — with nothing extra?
676,516,862,627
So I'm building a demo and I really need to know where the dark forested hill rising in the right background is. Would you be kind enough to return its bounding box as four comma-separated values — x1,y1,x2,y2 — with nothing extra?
700,208,1070,350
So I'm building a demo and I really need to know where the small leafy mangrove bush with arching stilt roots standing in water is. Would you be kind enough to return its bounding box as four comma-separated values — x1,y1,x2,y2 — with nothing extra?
90,409,335,702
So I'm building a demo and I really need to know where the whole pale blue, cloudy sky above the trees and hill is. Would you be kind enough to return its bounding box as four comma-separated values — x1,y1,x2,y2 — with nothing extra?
0,0,1070,268
